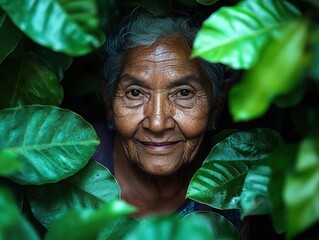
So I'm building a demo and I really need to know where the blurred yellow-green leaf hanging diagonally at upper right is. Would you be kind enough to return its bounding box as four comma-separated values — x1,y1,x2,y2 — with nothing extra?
229,21,308,121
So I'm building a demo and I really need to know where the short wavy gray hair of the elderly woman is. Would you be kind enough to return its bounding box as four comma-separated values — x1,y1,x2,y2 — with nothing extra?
102,9,226,106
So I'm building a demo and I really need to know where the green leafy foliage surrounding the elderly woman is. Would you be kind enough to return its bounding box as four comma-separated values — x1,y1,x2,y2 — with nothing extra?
0,0,319,239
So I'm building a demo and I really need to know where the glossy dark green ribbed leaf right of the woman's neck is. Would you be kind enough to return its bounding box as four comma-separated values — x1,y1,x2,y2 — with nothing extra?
186,128,282,209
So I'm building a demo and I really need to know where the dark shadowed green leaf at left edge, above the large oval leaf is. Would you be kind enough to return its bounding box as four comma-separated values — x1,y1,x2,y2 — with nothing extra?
0,52,63,108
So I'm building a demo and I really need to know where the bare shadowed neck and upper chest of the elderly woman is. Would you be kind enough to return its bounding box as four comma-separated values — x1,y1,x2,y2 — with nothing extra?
113,133,198,217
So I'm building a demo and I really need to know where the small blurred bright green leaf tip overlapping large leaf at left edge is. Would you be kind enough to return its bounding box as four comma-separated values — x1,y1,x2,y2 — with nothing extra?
0,149,22,176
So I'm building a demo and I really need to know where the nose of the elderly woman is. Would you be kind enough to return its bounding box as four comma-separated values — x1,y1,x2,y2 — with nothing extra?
143,94,175,132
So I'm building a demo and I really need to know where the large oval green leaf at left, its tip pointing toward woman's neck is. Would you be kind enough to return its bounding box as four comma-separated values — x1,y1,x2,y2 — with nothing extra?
0,105,99,184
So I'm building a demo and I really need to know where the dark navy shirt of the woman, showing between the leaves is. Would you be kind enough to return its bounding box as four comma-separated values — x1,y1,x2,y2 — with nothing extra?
92,122,241,230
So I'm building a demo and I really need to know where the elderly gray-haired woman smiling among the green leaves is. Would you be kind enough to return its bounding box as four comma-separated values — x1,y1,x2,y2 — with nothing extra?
94,7,237,229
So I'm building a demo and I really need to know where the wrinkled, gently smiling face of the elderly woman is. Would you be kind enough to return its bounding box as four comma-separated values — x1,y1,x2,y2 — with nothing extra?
112,38,212,175
